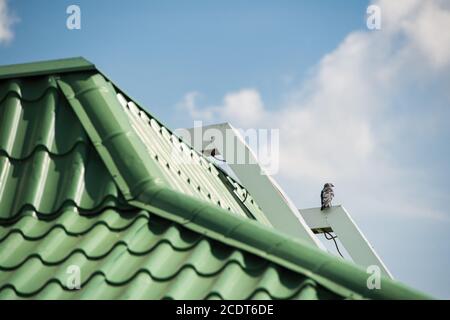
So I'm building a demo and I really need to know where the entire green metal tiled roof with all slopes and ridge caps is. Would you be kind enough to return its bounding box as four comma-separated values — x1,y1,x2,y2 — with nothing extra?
0,58,426,299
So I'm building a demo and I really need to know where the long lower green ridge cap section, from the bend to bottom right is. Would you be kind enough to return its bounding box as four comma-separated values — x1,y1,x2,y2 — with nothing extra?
130,186,431,300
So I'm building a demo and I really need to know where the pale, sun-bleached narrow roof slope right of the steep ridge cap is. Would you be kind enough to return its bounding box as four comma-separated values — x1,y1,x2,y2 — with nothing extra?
117,92,270,225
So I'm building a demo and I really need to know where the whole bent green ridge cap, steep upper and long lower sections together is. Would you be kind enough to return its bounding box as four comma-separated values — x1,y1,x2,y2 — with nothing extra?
52,65,430,299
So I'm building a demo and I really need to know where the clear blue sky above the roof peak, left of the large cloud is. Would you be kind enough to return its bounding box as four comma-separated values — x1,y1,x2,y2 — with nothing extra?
1,0,365,121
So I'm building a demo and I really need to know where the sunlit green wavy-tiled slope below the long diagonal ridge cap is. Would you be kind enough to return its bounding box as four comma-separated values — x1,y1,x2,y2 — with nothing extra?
0,209,341,299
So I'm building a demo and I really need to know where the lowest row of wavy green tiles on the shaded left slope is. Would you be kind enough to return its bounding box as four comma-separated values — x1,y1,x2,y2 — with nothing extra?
0,144,120,220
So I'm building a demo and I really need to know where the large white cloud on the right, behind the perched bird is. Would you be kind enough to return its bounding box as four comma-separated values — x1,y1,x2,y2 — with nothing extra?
178,0,450,219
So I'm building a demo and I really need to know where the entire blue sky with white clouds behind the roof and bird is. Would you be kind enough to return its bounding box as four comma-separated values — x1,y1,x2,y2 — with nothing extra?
0,0,450,298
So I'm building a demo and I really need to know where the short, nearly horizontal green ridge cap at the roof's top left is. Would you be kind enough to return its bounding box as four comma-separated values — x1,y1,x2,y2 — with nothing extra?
0,57,96,80
